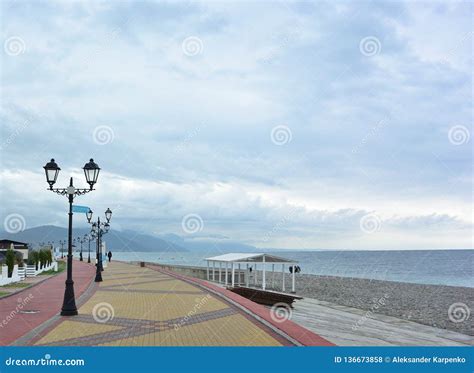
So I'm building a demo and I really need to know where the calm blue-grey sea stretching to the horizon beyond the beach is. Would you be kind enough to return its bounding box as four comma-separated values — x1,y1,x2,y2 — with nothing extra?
114,250,474,287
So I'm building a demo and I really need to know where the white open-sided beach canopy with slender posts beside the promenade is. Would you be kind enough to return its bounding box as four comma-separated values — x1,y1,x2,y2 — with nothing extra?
205,253,298,293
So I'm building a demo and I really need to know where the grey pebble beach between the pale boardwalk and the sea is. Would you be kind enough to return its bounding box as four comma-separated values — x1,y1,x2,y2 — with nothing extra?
258,274,474,336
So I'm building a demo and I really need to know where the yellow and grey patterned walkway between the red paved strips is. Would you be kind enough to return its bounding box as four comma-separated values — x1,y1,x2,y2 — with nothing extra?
20,262,330,346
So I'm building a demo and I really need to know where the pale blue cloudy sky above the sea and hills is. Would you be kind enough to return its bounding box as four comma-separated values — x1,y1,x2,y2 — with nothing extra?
0,0,473,249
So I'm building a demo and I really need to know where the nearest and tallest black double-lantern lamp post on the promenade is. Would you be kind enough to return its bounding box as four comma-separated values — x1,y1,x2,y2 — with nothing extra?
43,158,100,316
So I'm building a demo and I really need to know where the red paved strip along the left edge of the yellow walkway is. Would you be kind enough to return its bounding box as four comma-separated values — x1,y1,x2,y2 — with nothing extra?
0,260,95,346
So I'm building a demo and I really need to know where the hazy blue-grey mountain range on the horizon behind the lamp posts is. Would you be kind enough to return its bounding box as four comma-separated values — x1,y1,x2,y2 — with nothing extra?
0,225,187,252
